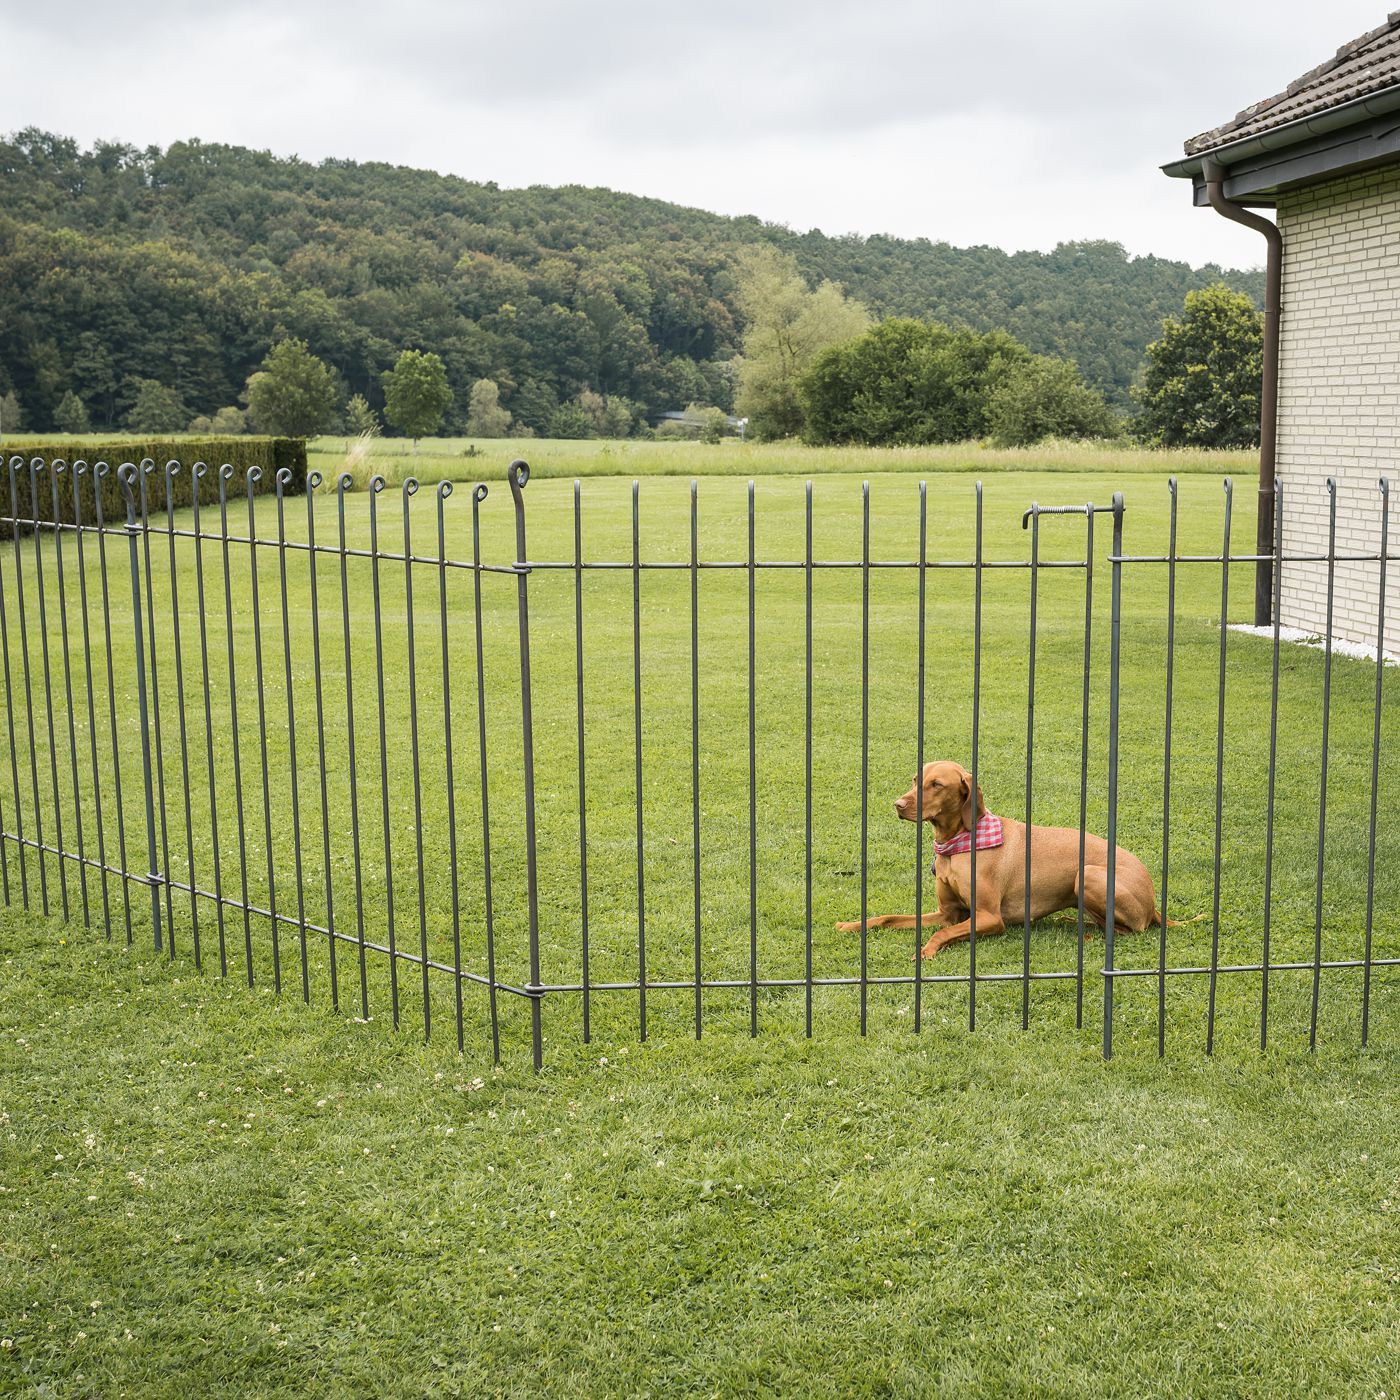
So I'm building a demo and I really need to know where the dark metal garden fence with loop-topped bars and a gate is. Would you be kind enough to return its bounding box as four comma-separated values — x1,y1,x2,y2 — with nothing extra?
0,458,1400,1067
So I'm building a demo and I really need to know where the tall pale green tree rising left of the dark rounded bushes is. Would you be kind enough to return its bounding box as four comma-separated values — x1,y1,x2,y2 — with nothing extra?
735,245,869,438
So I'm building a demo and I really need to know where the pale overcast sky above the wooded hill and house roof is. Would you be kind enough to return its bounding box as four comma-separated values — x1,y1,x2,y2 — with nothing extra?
0,0,1385,266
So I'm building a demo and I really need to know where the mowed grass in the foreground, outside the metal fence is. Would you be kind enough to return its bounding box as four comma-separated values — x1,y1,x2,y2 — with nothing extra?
0,913,1400,1397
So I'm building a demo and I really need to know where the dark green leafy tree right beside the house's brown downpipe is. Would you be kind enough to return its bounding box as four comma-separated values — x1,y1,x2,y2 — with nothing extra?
1137,283,1264,447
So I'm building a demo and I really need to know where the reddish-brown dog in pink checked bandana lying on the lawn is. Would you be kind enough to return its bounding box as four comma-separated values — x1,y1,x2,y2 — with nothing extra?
836,762,1162,958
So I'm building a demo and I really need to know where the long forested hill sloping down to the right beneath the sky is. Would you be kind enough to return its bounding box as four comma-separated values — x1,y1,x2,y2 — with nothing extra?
0,130,1261,430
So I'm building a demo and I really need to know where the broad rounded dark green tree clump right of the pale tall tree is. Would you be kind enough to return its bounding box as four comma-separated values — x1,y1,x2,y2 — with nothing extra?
799,318,1030,447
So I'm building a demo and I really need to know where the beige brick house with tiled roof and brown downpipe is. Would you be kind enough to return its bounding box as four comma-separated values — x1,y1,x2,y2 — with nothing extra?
1162,11,1400,652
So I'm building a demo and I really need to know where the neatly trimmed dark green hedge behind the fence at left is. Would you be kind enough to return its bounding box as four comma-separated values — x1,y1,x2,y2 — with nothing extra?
0,437,307,538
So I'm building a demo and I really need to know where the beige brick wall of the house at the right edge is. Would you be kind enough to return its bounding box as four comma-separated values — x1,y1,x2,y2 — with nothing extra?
1278,165,1400,652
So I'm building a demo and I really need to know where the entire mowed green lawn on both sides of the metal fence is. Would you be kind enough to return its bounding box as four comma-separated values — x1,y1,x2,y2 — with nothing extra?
0,445,1400,1394
